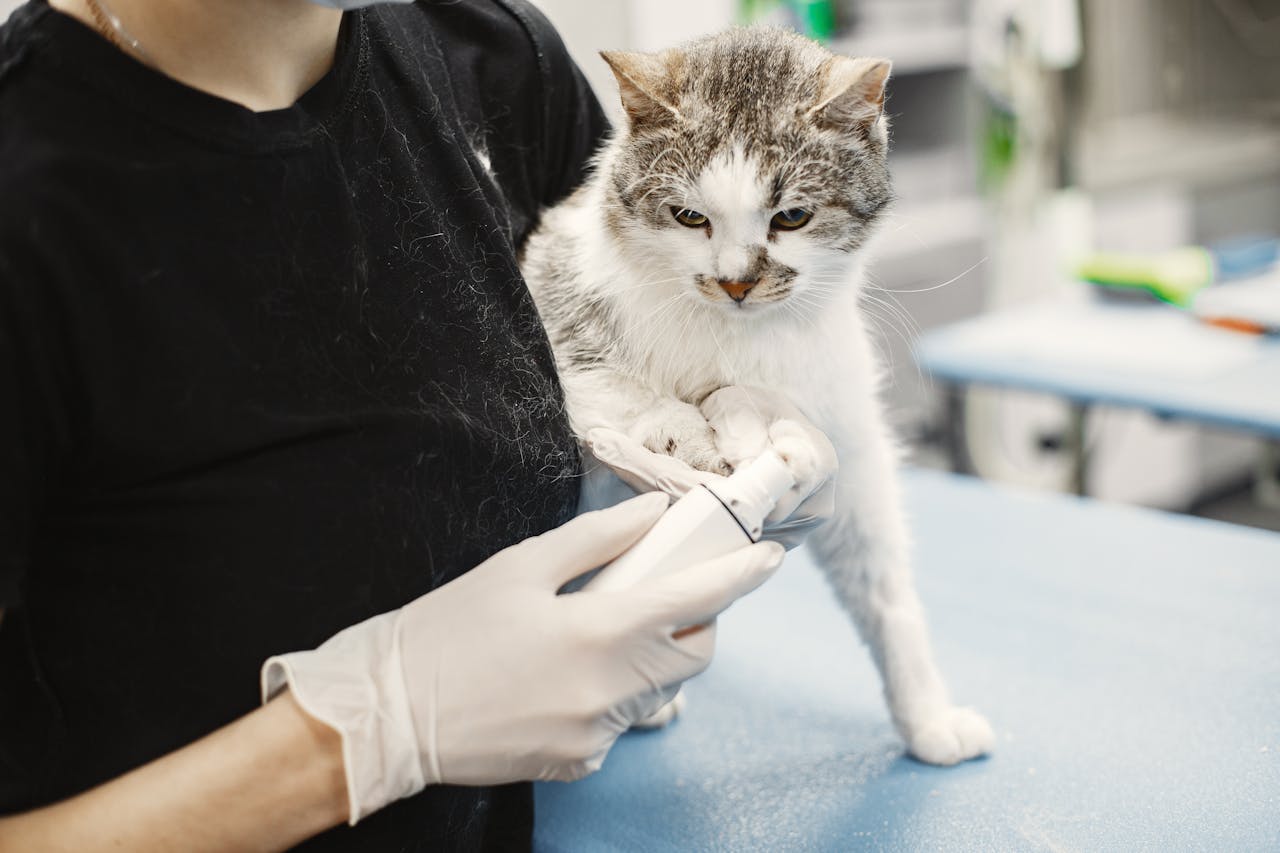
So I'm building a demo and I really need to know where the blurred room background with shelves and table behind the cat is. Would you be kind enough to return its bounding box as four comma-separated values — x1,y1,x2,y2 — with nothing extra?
536,0,1280,530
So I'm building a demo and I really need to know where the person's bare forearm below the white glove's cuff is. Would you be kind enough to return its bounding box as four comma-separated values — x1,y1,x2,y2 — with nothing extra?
0,693,347,853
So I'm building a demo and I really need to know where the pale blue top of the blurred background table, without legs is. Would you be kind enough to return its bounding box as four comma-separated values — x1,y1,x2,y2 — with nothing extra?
915,302,1280,438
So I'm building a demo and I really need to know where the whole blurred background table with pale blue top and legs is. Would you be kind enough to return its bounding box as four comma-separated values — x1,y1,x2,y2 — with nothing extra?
915,298,1280,493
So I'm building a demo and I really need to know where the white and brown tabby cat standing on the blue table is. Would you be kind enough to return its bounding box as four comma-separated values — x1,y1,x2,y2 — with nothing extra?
521,27,993,765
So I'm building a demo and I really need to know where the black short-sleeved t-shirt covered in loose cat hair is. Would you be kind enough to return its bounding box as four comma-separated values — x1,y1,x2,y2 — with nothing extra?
0,0,604,850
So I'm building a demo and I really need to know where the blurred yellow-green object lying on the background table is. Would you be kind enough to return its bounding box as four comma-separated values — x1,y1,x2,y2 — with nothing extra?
1075,246,1213,307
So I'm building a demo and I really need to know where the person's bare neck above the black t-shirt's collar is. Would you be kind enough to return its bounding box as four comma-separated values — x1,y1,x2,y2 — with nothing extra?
49,0,342,111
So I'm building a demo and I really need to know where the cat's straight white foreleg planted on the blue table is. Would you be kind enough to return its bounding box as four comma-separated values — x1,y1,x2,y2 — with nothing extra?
809,418,995,765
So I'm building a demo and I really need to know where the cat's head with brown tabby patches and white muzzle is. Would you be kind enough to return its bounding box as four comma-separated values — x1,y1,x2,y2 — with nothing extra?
602,27,892,316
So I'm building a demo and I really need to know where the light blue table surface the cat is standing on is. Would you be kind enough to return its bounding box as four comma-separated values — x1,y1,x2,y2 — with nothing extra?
535,471,1280,853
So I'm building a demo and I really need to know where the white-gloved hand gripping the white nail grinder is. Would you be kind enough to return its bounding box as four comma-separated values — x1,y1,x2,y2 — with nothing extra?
262,494,782,824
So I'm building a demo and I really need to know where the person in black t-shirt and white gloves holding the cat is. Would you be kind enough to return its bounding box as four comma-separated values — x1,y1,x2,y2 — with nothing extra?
0,0,834,850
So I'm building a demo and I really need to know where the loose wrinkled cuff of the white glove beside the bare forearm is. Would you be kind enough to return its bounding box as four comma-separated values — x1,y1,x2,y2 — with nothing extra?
261,611,426,826
